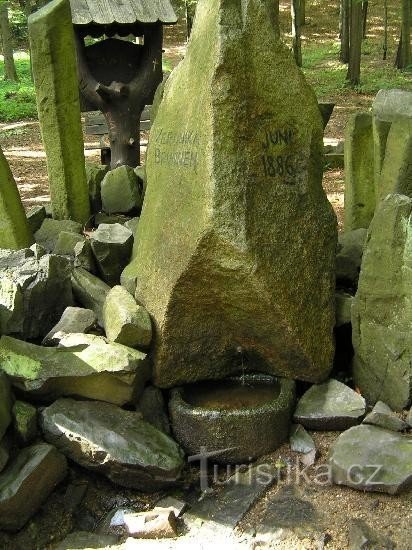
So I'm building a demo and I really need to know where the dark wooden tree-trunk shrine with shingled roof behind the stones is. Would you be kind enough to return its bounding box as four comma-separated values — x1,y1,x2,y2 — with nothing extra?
70,0,177,168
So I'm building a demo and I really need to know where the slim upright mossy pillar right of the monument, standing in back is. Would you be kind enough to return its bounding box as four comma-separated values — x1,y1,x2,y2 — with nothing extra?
345,113,376,231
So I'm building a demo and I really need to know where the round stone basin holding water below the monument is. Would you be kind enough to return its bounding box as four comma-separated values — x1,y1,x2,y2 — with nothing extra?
169,374,295,463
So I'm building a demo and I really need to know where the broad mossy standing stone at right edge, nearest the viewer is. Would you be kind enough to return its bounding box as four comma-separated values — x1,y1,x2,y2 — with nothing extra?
352,195,412,410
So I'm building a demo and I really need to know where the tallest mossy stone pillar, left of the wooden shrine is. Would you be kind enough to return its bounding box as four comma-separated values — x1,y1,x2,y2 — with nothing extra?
29,0,90,223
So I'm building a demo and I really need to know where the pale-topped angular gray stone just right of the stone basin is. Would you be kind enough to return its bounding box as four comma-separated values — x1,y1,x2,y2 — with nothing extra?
294,379,366,431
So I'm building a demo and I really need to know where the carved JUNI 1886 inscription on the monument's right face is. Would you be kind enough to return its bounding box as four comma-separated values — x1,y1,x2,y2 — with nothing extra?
261,127,304,185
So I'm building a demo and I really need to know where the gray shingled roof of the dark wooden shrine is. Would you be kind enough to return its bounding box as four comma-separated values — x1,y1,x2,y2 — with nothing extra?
70,0,177,26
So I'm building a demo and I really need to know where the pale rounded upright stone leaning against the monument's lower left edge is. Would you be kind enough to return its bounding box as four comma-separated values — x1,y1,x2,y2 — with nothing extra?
103,286,152,349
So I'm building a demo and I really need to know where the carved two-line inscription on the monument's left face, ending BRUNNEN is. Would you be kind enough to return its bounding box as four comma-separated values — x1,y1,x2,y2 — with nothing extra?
154,128,200,172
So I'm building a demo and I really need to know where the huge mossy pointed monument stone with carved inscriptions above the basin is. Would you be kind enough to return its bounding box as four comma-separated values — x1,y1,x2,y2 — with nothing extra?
122,0,337,387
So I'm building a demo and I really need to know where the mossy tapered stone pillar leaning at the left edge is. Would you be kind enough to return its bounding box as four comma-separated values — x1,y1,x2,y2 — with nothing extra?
0,149,33,250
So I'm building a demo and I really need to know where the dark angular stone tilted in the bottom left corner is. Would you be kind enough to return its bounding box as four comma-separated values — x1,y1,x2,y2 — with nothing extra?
0,443,67,531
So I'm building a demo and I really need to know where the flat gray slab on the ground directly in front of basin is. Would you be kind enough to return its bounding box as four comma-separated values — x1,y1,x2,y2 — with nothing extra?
185,466,278,529
